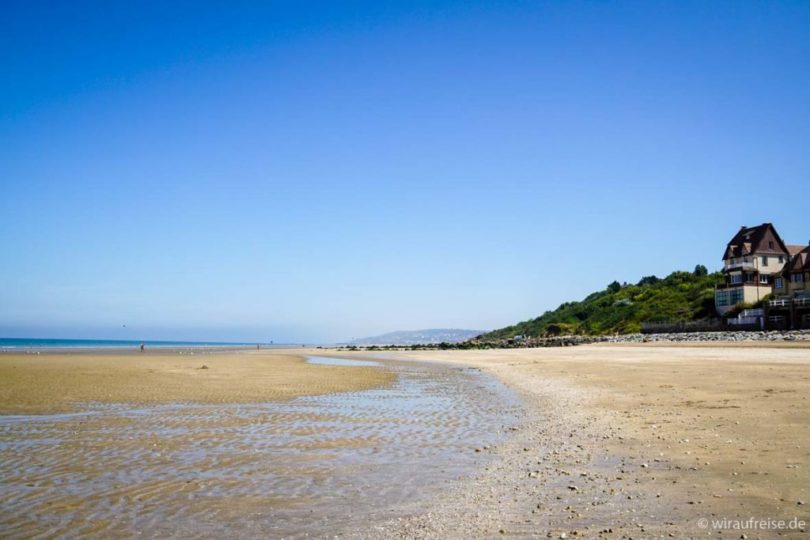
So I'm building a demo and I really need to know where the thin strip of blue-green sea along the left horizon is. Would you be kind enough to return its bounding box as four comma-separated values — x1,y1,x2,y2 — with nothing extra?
0,338,280,351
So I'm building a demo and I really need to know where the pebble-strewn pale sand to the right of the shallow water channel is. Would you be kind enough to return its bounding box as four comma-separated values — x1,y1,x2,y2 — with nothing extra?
346,344,810,538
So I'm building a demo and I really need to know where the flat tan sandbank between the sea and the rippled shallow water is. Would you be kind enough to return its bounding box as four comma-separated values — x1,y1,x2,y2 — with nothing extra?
0,350,394,414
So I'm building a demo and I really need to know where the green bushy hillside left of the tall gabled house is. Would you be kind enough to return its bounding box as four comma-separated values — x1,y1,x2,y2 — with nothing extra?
480,266,723,340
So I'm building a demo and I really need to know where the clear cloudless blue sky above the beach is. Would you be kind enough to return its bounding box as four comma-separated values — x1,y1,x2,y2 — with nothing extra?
0,1,810,342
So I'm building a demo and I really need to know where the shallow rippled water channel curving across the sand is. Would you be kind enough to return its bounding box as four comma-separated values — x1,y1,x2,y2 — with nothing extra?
0,357,520,538
